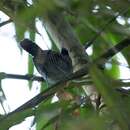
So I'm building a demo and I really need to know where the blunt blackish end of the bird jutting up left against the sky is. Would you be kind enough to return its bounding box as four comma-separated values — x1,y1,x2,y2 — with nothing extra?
20,39,41,56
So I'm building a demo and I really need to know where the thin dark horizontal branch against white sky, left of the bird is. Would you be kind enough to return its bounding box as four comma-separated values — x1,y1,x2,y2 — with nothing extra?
0,72,44,82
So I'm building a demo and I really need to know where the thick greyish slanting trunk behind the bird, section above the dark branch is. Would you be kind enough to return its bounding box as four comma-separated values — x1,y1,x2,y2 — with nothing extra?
43,10,89,71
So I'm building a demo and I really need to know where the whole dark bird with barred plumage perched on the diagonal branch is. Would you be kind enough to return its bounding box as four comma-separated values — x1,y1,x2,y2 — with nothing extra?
20,39,73,85
